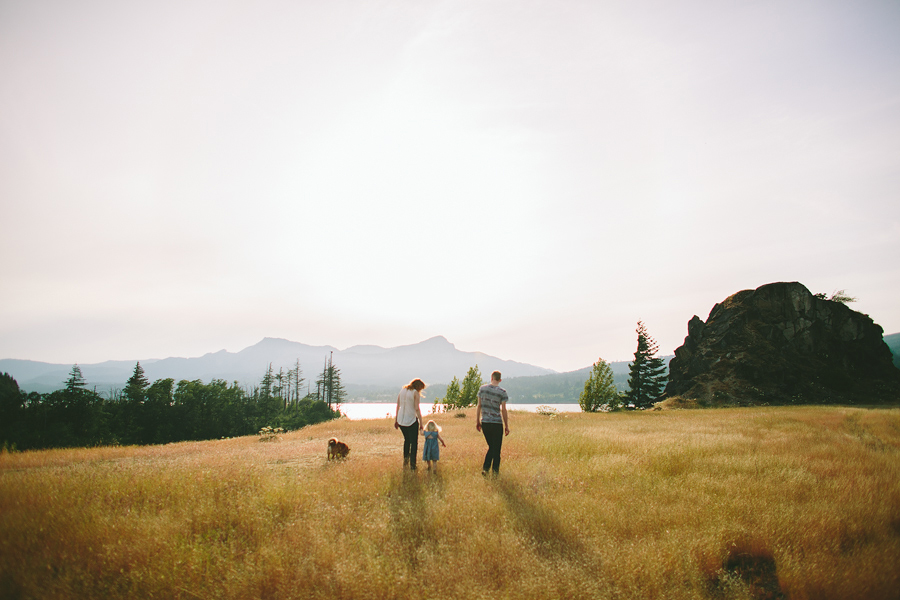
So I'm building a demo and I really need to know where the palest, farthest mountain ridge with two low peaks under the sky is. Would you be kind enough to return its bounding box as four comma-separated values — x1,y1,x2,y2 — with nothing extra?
0,336,555,393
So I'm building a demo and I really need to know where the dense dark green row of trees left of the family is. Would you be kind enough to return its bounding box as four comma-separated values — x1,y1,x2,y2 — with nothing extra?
0,358,346,450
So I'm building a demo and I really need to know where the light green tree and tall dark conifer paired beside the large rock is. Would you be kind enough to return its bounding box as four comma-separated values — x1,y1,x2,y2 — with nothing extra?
578,321,666,412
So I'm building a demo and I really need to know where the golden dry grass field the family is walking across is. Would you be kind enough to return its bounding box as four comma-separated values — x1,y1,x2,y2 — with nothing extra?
0,407,900,600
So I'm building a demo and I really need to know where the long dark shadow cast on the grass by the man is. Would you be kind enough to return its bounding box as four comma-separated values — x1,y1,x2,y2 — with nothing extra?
492,479,585,561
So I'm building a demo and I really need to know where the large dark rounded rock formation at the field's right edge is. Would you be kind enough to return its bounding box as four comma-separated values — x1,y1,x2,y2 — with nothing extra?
664,283,900,406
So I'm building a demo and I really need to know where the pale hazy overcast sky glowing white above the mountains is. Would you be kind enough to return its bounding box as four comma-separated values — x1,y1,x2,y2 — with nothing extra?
0,0,900,371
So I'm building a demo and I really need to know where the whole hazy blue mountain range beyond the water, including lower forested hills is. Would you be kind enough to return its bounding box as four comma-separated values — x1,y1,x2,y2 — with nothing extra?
0,333,900,404
